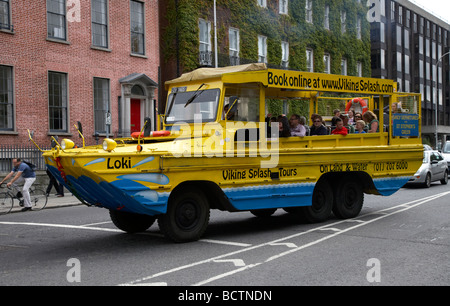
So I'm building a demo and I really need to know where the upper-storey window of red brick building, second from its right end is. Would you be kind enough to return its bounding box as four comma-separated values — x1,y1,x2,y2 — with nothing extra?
91,0,108,48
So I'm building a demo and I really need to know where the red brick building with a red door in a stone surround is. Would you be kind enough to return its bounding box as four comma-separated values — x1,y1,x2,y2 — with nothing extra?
0,0,160,145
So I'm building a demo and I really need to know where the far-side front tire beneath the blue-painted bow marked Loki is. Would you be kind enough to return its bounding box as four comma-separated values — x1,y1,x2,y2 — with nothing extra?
109,210,156,234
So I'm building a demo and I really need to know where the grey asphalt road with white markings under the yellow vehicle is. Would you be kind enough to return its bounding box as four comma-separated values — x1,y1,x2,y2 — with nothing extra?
0,183,450,287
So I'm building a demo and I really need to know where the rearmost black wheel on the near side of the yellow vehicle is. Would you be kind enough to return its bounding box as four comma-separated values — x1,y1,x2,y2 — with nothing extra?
333,179,364,219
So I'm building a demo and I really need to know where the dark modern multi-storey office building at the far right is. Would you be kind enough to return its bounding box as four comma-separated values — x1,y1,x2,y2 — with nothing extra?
371,0,450,145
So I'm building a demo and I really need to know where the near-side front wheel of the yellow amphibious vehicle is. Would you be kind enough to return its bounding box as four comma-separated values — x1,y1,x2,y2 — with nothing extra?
158,188,209,242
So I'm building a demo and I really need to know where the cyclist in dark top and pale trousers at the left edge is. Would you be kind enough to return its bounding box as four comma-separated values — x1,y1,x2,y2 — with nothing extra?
0,158,36,211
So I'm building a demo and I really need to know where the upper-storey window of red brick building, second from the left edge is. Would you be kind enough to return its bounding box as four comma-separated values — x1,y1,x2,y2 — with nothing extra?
47,0,67,40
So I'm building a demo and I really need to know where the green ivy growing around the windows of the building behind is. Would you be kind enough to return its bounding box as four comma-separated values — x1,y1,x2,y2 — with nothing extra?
162,0,371,117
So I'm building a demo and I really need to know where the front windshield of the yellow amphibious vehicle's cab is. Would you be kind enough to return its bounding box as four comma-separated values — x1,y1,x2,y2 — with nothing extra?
166,89,220,124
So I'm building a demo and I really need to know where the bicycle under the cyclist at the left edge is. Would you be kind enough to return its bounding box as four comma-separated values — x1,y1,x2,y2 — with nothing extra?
0,186,48,215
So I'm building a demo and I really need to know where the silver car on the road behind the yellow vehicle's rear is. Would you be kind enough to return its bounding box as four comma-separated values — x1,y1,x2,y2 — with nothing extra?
408,151,448,188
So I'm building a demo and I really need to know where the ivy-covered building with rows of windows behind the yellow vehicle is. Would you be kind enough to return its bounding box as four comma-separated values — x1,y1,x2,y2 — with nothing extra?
160,0,371,92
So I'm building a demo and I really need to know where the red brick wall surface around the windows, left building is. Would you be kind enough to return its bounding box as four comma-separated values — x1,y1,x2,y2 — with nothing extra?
0,0,159,144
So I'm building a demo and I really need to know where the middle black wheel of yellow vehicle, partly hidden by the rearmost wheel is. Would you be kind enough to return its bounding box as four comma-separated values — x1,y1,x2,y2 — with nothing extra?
298,180,333,223
